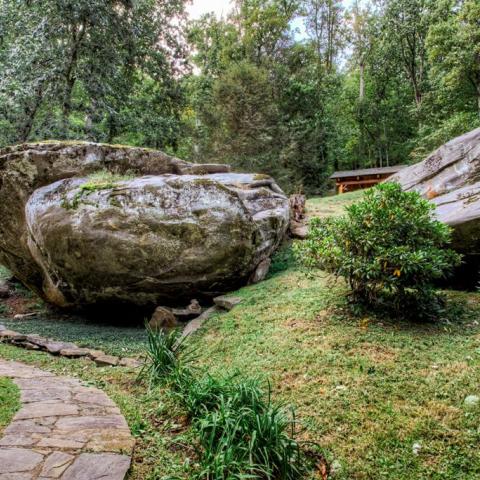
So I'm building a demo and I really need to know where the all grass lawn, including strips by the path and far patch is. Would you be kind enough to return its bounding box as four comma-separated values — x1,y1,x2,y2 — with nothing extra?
0,193,480,480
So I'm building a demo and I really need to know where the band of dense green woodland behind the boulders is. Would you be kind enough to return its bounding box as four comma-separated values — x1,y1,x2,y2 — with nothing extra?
0,0,480,193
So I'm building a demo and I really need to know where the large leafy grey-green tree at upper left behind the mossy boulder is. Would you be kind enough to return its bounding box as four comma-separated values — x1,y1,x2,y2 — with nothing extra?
0,0,188,148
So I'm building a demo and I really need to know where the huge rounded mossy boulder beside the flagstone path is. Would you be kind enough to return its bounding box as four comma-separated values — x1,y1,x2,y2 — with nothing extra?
0,142,289,307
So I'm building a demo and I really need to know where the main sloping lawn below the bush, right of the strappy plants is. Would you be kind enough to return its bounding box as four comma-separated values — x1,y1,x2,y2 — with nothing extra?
188,262,480,479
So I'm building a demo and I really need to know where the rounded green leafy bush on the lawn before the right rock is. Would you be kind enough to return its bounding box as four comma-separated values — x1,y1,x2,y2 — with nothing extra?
295,183,461,317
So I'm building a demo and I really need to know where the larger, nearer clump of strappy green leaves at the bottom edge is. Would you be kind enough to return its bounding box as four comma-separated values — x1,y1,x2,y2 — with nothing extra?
190,380,308,480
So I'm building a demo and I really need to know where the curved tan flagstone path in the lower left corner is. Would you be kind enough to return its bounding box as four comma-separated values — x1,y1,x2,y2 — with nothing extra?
0,359,135,480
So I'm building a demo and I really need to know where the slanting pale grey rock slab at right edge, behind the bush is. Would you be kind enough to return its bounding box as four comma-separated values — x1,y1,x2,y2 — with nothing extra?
389,128,480,254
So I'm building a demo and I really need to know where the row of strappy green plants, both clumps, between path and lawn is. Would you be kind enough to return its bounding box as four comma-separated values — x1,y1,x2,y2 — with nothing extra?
139,328,316,480
